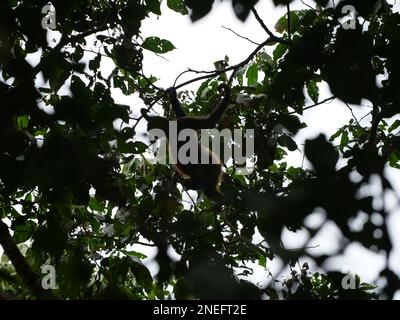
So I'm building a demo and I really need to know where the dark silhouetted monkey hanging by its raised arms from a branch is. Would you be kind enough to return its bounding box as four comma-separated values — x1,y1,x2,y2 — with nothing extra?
141,84,230,203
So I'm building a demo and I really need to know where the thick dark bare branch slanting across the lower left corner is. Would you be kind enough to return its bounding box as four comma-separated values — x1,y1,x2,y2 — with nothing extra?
0,220,58,300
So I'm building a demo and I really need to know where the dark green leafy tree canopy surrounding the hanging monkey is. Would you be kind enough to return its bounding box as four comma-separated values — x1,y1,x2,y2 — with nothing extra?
0,0,400,299
